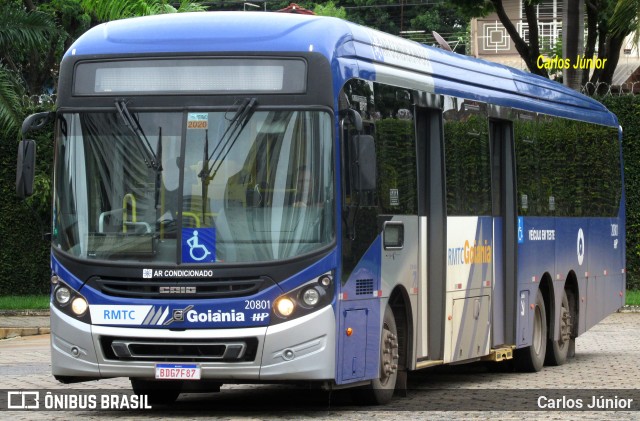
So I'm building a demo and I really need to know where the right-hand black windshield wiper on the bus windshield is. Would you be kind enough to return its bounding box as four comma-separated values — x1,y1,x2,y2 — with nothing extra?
198,98,258,185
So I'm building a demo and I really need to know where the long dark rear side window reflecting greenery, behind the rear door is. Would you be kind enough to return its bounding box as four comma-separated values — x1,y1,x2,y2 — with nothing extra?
514,118,621,217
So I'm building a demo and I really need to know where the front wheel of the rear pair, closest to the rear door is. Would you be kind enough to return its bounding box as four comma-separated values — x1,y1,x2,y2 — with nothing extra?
515,290,547,372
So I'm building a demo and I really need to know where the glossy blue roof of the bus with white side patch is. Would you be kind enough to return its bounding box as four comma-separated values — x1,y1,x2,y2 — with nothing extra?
65,12,618,127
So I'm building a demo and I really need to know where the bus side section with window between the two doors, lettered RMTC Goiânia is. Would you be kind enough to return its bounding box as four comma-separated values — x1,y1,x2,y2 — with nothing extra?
440,97,499,363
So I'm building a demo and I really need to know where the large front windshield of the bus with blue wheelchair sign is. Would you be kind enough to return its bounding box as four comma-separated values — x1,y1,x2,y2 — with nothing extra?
53,108,335,264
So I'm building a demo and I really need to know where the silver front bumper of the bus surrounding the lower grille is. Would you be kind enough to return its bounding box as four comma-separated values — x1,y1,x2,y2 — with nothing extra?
51,306,336,383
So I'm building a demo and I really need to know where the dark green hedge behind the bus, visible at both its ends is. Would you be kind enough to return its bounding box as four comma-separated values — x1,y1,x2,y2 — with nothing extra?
0,96,640,295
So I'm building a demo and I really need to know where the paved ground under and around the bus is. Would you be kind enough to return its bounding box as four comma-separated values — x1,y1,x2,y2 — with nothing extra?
0,313,640,421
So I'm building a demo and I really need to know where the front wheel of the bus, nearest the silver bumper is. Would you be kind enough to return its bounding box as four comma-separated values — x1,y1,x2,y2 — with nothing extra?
353,305,398,405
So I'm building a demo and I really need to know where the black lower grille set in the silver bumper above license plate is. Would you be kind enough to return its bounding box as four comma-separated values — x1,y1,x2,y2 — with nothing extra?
100,336,258,362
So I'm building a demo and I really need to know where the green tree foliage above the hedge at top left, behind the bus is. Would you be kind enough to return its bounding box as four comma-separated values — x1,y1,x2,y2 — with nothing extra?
0,0,210,137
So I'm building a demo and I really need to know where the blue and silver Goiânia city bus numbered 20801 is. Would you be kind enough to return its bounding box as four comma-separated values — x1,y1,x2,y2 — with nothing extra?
17,13,625,403
